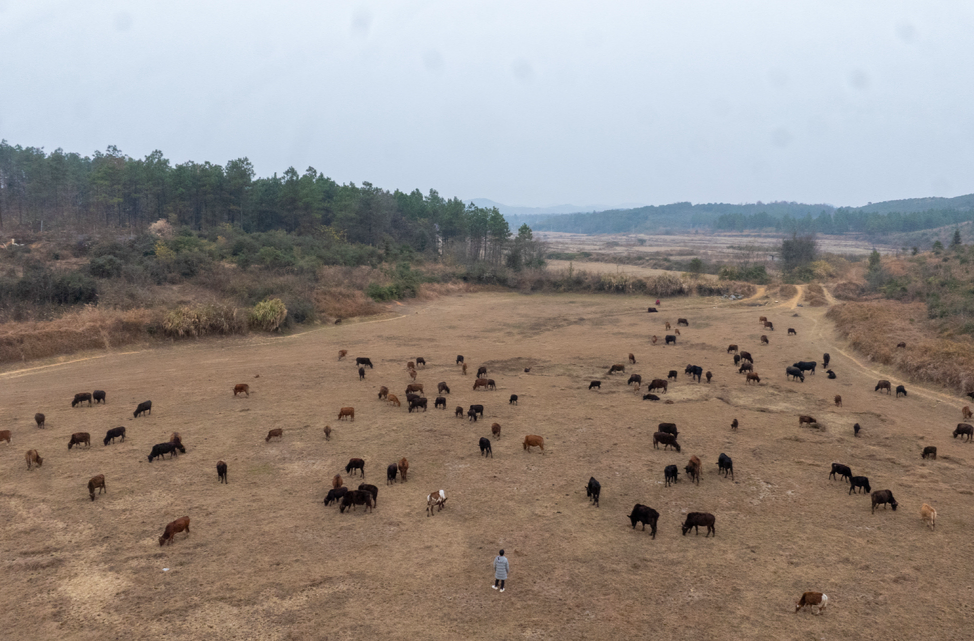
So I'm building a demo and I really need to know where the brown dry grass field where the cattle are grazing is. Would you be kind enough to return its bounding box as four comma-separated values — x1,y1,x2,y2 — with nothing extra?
0,294,974,641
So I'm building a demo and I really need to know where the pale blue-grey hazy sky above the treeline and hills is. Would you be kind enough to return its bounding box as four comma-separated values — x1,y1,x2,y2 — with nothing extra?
0,0,974,206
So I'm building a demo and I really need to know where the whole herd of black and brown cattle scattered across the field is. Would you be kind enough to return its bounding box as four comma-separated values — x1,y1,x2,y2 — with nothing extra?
7,308,974,614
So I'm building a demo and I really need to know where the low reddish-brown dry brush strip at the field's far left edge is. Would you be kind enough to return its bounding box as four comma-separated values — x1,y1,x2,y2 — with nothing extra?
0,305,153,363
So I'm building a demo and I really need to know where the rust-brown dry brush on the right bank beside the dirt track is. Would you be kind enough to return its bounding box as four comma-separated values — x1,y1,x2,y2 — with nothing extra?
826,301,974,391
